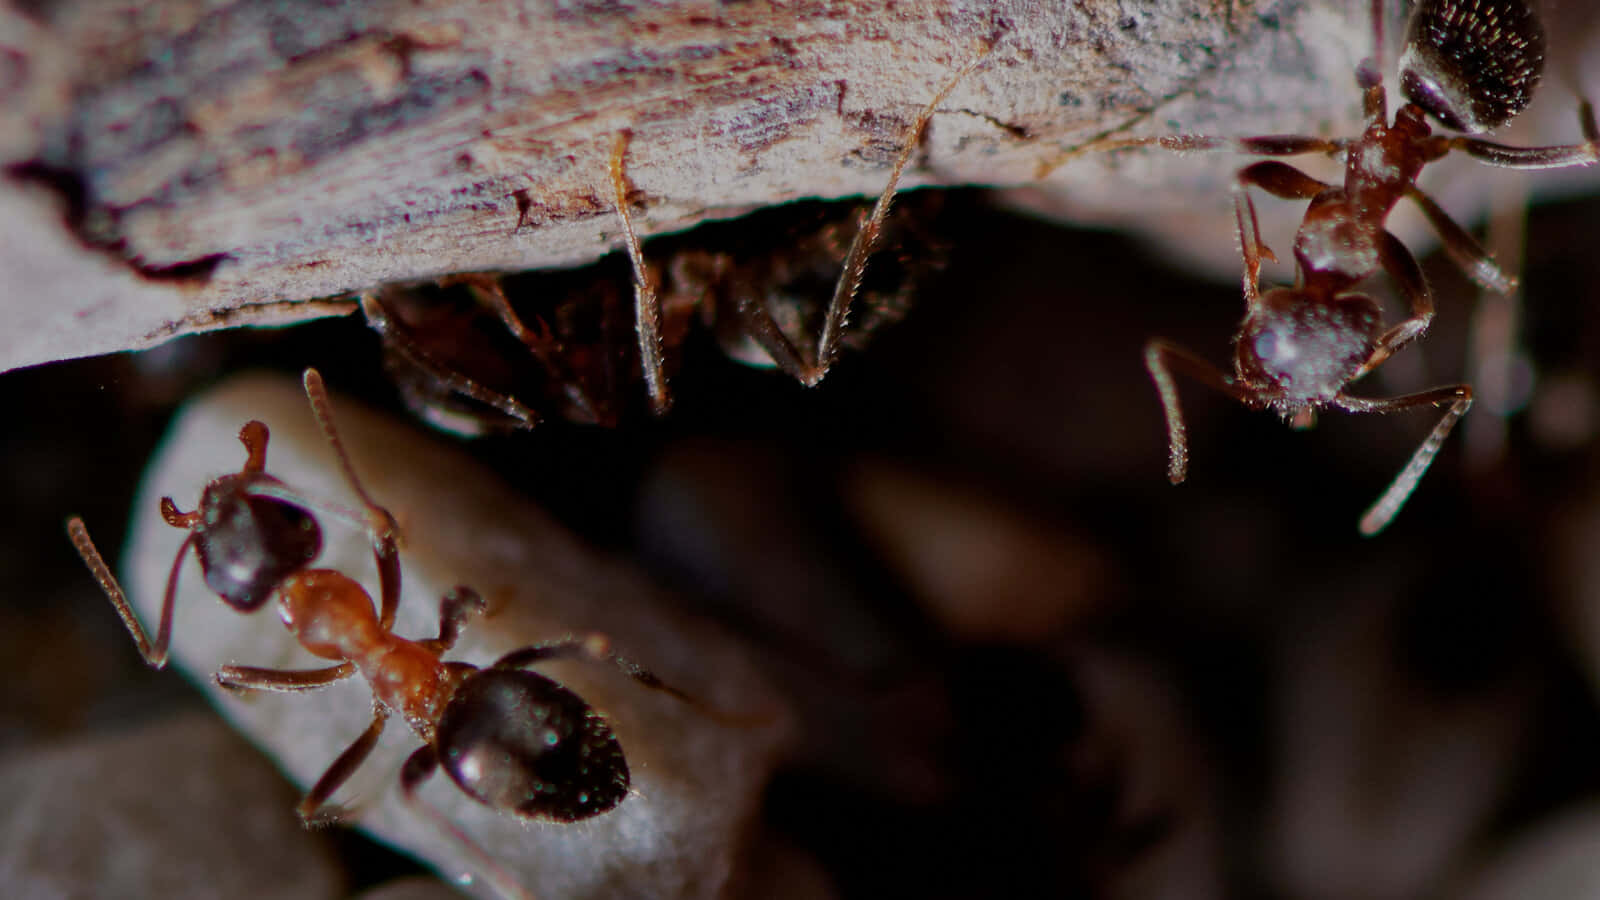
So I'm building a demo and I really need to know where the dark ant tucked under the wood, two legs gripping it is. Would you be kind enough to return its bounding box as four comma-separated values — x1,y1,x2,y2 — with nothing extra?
360,43,989,434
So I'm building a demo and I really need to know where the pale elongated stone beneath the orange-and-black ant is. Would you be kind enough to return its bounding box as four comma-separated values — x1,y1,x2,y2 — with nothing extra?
123,368,800,898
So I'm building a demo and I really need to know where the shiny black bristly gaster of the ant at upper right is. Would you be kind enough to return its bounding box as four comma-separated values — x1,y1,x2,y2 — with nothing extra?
1400,0,1544,135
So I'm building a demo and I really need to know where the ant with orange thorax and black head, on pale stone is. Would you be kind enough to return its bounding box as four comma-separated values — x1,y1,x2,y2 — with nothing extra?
67,368,733,898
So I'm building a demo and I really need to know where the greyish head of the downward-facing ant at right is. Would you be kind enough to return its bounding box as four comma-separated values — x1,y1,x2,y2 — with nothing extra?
1234,288,1382,408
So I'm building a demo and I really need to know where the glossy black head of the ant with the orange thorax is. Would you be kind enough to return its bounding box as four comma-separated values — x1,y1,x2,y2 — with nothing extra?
192,471,322,612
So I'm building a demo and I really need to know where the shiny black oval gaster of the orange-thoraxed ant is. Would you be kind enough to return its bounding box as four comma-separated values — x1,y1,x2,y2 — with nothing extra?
434,669,629,822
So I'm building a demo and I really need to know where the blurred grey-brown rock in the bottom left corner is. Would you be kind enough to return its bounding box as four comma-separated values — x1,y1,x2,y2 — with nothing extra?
0,714,342,900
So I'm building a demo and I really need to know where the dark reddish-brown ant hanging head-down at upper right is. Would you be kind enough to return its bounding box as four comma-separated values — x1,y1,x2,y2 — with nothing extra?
1110,0,1600,535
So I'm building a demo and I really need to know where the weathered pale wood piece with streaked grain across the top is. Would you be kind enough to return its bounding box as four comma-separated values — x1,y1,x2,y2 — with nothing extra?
0,0,1592,370
